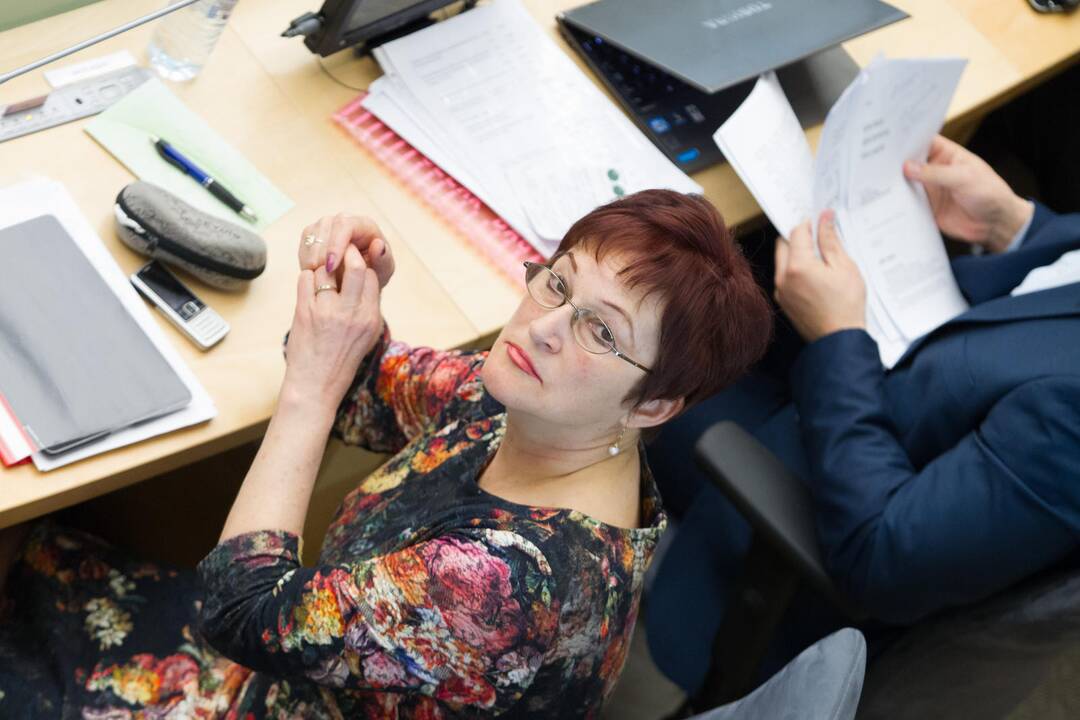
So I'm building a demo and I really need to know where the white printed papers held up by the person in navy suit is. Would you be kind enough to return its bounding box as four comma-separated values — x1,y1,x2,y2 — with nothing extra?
714,57,968,367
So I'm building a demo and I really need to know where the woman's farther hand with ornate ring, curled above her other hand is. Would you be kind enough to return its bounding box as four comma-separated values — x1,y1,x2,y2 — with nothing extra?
300,213,394,288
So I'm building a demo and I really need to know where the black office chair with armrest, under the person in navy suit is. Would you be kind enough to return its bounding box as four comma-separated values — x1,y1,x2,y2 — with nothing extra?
689,422,1080,720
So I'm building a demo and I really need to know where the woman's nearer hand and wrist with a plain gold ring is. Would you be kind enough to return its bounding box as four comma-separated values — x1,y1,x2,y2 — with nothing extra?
281,243,382,415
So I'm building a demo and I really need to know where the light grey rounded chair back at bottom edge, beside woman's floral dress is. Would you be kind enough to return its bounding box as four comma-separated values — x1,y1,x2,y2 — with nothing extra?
694,627,866,720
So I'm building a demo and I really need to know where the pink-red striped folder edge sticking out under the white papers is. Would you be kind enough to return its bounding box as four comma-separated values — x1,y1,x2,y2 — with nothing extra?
334,93,544,285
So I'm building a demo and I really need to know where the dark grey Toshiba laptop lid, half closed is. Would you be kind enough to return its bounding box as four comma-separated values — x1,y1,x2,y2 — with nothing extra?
559,0,907,93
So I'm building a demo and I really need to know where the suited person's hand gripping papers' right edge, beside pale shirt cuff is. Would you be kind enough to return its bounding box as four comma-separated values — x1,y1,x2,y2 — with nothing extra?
904,135,1035,253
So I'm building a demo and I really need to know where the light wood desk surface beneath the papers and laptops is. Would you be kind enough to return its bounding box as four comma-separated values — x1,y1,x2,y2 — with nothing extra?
0,0,1080,527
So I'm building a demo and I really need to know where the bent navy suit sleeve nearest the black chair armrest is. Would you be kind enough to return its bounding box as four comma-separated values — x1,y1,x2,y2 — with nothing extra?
792,330,1080,624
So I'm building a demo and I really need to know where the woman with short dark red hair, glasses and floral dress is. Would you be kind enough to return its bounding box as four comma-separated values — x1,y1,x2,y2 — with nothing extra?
0,190,771,718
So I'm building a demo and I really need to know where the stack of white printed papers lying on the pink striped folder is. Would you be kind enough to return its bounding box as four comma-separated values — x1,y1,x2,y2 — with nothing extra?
363,0,701,256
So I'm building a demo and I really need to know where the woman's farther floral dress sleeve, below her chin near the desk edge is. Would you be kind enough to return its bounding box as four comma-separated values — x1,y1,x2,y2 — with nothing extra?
332,329,486,452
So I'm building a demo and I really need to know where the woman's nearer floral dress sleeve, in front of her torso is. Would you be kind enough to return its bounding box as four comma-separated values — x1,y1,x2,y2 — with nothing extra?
199,529,558,712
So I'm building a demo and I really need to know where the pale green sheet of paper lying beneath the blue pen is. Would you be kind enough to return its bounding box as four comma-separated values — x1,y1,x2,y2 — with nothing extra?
86,78,293,231
